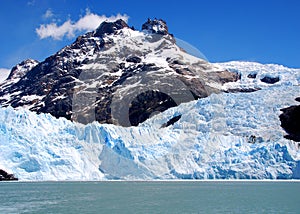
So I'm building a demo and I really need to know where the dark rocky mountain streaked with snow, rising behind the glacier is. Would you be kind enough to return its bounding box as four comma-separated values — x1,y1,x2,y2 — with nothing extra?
0,19,240,126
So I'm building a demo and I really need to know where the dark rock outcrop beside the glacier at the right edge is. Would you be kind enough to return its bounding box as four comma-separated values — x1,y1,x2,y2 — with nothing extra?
279,99,300,142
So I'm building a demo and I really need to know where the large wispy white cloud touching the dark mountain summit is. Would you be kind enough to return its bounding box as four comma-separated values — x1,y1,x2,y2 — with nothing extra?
35,10,129,40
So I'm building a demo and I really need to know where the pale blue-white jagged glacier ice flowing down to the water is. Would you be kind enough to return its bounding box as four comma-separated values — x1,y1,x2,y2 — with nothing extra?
0,62,300,181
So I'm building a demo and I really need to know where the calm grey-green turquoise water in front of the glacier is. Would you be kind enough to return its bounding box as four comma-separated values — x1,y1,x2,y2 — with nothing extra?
0,181,300,214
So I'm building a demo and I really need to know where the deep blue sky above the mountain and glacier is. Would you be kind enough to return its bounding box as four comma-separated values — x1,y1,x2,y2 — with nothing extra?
0,0,300,68
